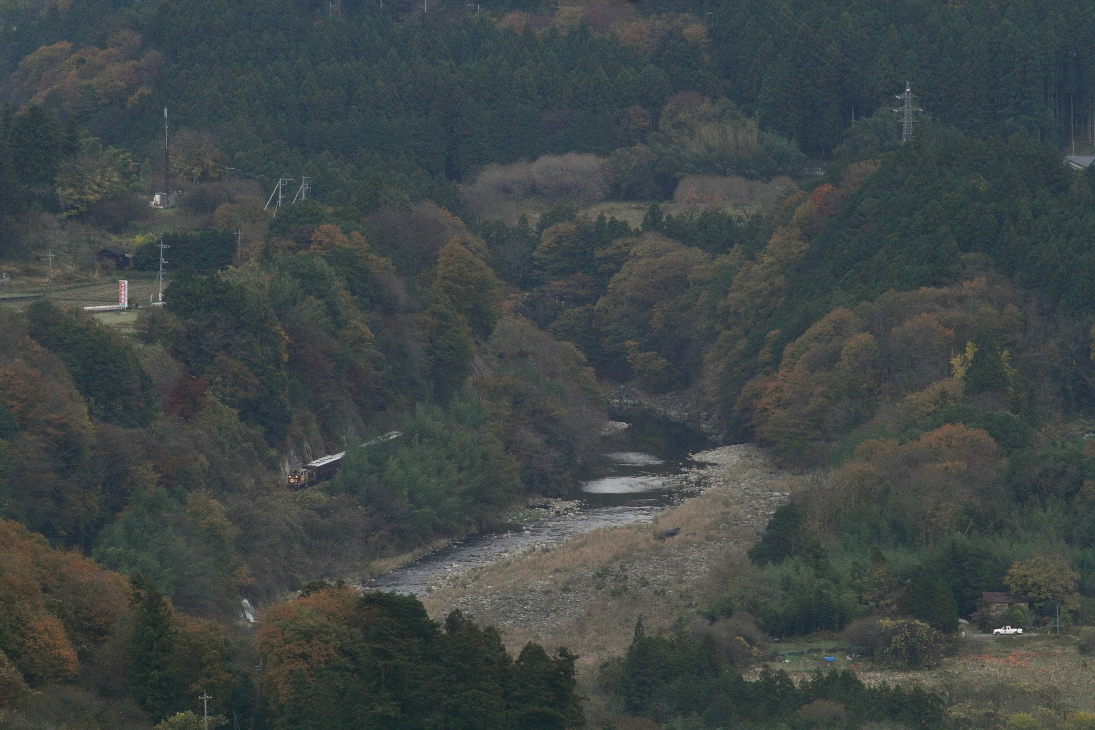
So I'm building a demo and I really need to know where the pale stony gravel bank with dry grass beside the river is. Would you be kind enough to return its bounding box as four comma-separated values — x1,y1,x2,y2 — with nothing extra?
424,444,787,681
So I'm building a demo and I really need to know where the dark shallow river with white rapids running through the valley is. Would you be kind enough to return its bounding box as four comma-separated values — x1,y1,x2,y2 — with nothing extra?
369,420,711,596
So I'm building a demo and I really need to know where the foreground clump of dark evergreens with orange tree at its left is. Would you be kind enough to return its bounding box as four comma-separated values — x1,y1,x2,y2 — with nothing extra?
257,586,583,730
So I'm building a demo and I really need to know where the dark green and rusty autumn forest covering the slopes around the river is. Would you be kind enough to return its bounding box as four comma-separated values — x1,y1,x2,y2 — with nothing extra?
6,0,1095,728
